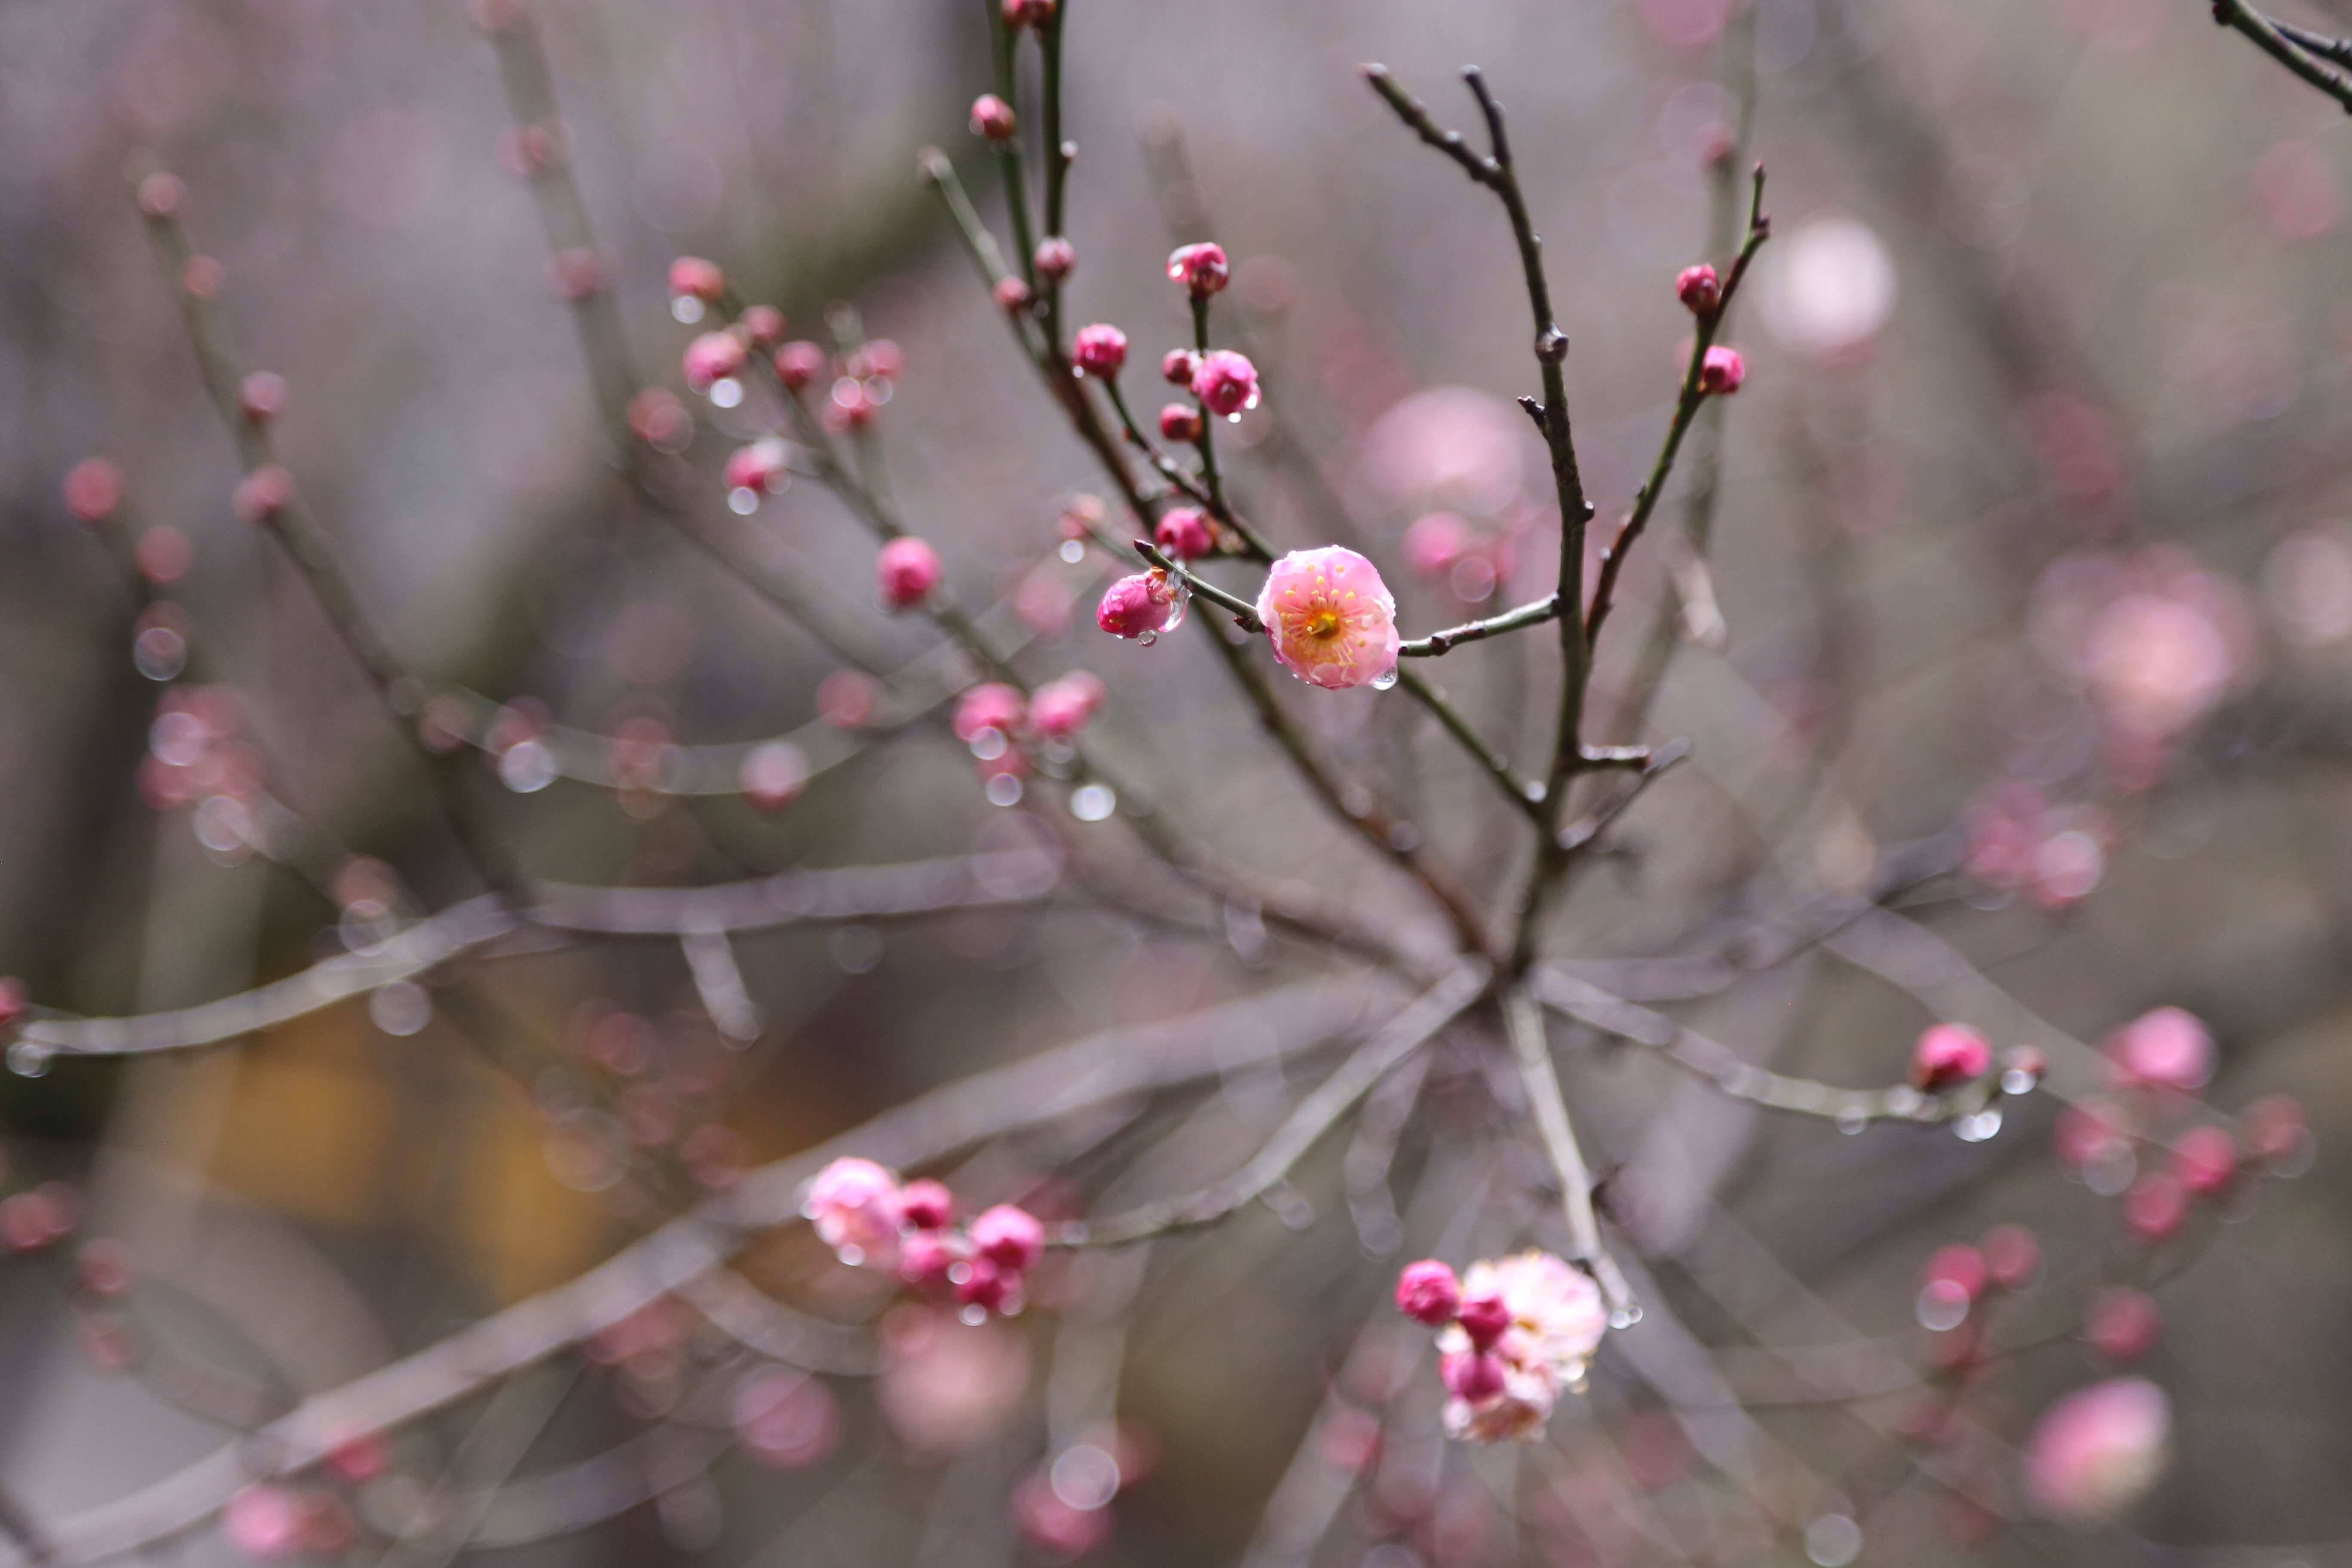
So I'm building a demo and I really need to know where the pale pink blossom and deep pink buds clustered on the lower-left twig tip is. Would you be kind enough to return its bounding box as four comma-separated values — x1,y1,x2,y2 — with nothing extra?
799,1157,1044,1323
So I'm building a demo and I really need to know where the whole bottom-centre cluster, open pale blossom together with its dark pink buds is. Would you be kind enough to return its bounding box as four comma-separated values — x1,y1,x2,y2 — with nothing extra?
1397,1251,1609,1443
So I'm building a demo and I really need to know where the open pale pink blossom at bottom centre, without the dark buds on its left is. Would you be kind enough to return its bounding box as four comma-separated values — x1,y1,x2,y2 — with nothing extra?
1437,1251,1609,1443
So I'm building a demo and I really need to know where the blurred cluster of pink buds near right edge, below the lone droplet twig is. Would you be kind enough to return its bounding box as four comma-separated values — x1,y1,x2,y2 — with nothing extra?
2053,1006,2312,1246
